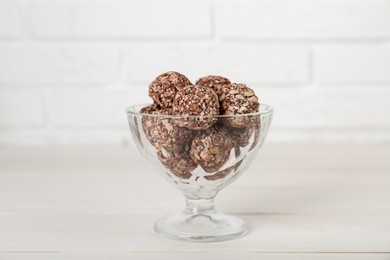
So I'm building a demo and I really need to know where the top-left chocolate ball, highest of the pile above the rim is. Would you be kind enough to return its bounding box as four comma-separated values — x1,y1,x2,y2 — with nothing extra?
149,71,191,108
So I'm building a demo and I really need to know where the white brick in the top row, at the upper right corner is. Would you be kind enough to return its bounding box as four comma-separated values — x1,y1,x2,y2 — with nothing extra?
217,0,390,40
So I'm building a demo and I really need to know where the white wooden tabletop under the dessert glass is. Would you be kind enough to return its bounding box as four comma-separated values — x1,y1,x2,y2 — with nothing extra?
0,146,390,260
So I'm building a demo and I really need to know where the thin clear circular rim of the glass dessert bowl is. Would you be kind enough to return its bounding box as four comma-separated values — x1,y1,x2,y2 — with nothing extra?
125,103,274,119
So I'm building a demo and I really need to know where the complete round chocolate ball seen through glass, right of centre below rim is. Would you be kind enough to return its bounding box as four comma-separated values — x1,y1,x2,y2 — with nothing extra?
190,125,234,173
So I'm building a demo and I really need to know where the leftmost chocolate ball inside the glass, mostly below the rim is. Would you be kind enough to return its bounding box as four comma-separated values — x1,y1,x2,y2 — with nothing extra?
143,108,192,150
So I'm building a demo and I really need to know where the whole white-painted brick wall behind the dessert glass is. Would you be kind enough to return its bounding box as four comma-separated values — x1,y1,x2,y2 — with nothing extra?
0,0,390,145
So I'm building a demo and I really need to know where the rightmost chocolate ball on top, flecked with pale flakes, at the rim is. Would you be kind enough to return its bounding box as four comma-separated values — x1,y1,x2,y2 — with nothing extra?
220,83,259,127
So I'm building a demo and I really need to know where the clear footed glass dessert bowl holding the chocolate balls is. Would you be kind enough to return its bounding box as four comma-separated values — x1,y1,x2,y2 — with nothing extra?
126,104,273,242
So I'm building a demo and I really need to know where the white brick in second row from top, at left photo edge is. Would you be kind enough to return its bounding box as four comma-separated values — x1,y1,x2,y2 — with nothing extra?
0,43,121,84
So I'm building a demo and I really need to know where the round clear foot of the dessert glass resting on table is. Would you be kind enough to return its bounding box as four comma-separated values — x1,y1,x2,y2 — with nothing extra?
154,212,248,242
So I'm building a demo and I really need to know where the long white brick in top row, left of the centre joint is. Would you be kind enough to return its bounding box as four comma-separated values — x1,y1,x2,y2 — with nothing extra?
31,0,211,38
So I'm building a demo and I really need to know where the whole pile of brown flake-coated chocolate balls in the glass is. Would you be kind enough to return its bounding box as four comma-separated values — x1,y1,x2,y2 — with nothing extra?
140,71,260,181
